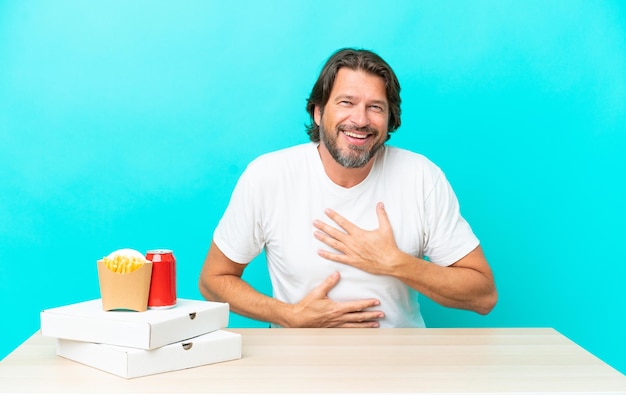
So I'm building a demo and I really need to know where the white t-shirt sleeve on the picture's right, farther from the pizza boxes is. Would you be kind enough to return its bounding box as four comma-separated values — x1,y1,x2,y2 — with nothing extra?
424,171,480,266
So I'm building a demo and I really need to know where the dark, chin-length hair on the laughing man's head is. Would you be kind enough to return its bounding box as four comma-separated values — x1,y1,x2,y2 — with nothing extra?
306,48,401,142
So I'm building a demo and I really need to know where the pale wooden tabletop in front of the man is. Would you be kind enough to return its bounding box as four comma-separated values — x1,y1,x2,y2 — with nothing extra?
0,328,626,394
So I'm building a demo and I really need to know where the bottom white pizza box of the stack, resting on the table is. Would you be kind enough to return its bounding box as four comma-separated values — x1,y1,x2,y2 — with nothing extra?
57,330,241,378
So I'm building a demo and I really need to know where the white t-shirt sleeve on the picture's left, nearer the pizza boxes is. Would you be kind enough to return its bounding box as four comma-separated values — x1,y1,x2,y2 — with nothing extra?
213,166,265,264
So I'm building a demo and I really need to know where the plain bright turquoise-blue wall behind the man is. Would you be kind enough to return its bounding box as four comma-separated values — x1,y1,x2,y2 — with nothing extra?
0,0,626,372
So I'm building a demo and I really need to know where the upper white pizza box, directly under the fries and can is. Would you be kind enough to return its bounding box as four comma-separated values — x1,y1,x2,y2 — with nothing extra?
40,299,229,350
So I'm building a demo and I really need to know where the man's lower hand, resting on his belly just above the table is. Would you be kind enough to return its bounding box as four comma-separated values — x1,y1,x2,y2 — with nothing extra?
288,272,385,328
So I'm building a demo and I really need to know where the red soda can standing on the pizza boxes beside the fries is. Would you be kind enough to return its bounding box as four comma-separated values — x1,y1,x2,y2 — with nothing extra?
146,249,176,309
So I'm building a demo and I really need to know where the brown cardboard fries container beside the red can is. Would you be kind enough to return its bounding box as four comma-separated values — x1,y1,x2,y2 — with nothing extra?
98,260,152,311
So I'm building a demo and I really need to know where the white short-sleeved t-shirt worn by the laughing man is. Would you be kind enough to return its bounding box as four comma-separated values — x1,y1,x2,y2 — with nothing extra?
214,143,479,327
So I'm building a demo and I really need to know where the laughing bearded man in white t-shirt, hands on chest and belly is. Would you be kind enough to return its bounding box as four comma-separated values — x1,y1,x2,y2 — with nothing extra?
200,49,497,327
